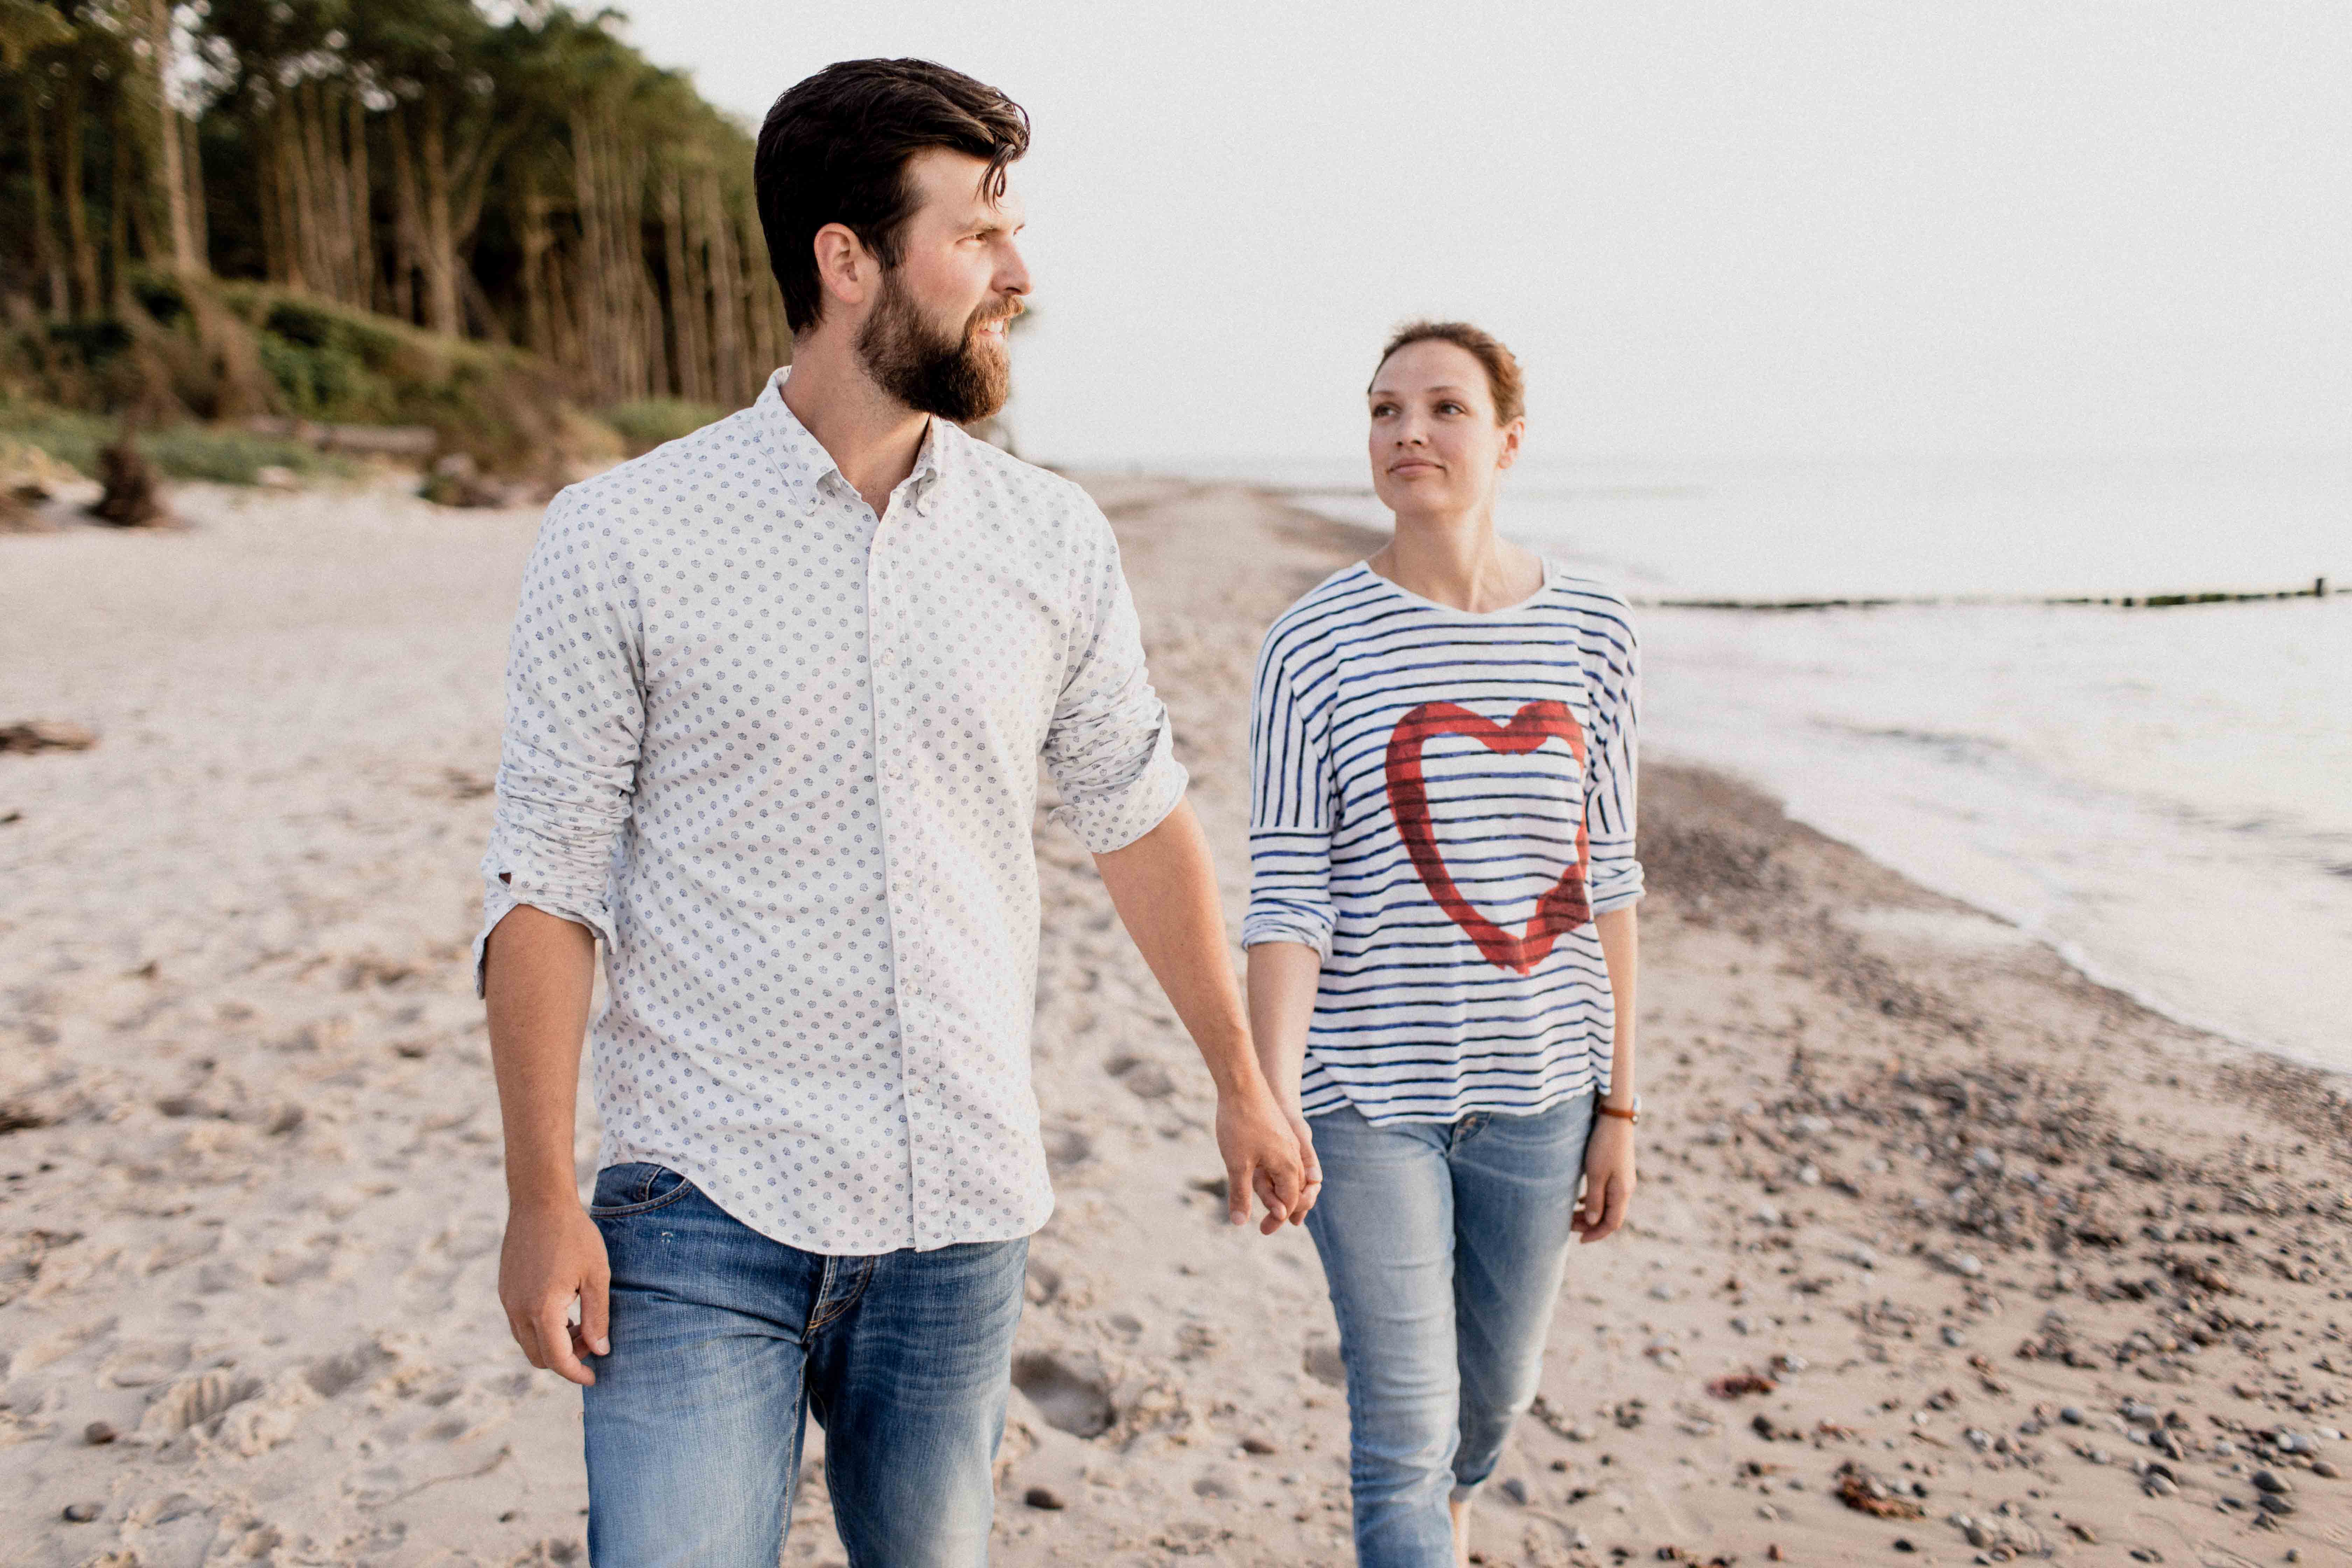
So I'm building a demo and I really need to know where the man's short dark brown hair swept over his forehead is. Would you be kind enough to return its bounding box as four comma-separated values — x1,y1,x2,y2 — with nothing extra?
752,59,1028,334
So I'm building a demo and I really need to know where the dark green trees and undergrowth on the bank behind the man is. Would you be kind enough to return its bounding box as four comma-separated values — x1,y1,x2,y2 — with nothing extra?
0,0,790,475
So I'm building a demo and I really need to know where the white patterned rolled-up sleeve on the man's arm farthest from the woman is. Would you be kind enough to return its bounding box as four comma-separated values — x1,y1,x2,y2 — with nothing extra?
473,491,644,992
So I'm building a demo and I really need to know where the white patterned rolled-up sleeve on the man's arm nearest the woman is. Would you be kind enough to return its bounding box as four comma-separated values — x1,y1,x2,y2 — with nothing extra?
1044,501,1188,856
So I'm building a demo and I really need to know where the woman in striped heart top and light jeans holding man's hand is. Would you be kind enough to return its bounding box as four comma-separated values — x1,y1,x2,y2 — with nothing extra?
1242,322,1642,1568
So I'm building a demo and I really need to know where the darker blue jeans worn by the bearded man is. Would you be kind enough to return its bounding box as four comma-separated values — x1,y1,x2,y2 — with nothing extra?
586,1166,1028,1568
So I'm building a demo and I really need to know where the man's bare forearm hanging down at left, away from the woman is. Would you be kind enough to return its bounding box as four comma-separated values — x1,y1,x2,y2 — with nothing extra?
482,905,595,1208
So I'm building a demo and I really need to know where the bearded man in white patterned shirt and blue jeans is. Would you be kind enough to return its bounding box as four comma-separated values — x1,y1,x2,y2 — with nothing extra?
477,61,1312,1568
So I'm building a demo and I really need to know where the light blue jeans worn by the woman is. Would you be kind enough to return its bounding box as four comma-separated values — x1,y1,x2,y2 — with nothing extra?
1308,1093,1592,1568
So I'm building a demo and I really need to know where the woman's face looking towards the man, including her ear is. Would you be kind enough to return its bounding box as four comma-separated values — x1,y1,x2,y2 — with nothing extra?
1369,338,1526,517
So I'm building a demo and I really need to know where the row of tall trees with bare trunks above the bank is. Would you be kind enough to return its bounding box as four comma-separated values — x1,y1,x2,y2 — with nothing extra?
0,0,790,407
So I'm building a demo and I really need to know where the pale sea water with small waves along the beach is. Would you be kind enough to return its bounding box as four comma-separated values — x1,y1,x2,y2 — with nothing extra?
1251,456,2352,1070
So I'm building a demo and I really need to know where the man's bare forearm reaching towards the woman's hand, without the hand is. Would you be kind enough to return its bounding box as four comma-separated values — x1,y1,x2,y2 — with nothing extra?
1094,802,1265,1096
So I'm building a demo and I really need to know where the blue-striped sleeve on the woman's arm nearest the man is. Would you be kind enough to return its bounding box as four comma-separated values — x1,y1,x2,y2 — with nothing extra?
1242,628,1336,959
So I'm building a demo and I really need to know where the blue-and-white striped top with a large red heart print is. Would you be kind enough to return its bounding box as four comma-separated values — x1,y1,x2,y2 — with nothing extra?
1242,564,1642,1121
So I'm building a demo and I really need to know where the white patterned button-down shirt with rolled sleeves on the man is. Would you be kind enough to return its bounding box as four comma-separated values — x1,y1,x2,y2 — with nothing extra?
475,371,1185,1253
